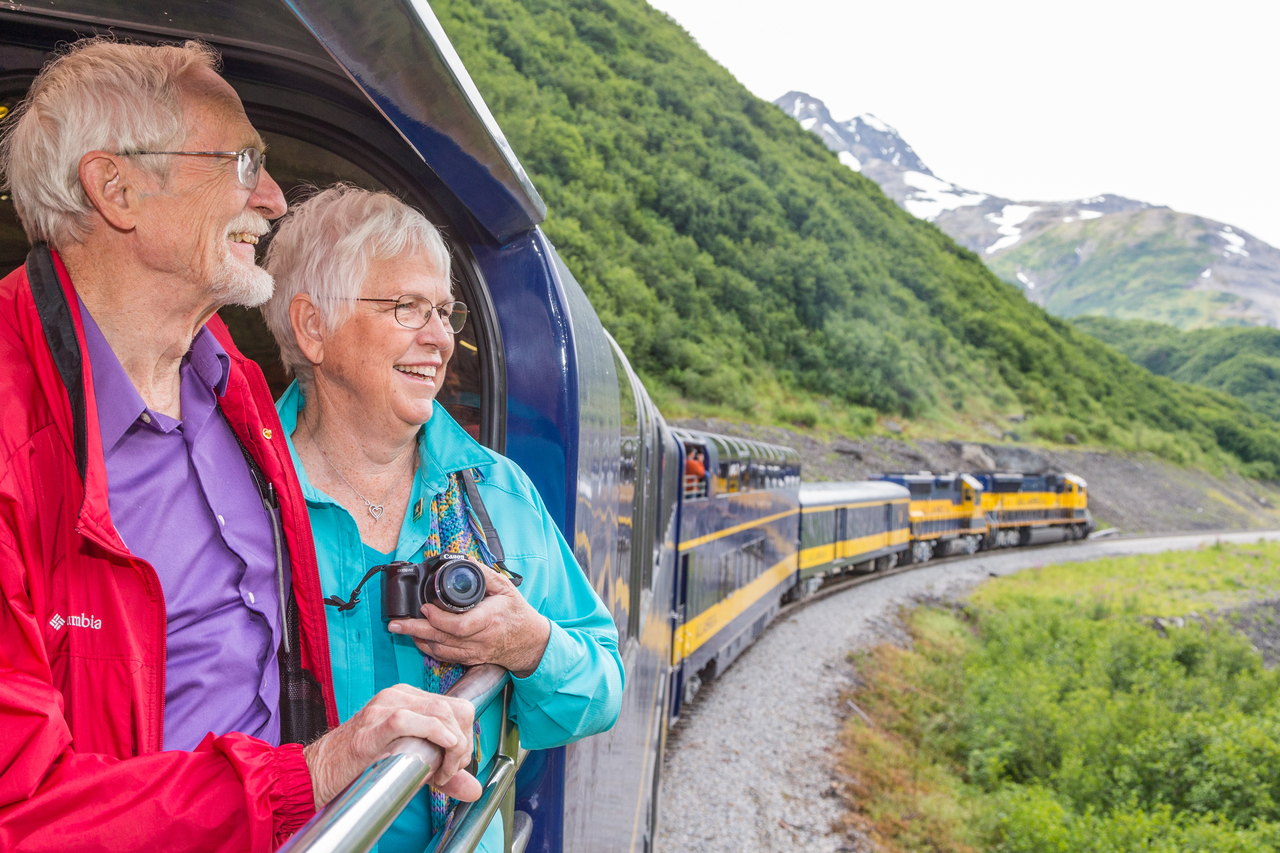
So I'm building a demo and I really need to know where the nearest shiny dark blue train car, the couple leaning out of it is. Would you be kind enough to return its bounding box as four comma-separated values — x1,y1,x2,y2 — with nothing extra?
0,0,680,853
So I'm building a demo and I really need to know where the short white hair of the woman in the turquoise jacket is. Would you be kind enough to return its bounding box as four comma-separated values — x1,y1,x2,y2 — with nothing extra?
262,183,452,384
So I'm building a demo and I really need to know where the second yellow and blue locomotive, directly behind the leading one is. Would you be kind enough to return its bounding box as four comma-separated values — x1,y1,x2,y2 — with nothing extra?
881,471,988,562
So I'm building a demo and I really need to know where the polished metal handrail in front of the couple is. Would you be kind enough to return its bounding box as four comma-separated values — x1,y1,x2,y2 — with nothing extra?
280,663,516,853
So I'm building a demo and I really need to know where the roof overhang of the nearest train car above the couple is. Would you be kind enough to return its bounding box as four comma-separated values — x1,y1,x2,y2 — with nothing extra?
6,0,547,241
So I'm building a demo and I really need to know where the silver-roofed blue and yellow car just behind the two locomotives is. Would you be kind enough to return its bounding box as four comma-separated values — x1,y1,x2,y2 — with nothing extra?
799,480,911,592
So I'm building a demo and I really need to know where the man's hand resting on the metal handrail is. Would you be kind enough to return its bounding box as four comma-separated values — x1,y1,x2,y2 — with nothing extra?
302,684,480,808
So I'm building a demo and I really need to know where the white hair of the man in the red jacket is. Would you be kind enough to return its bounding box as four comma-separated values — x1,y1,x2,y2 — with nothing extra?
0,37,220,247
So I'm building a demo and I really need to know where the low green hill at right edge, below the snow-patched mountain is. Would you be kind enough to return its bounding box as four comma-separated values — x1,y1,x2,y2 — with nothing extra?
1075,316,1280,420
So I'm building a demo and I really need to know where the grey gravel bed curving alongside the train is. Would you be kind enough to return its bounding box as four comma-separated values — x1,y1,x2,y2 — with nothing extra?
658,530,1280,853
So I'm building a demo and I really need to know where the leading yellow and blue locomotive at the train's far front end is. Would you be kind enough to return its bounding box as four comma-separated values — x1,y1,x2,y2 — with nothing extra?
974,471,1094,547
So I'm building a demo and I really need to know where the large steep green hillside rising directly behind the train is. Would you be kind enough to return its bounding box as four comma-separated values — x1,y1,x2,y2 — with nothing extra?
433,0,1280,475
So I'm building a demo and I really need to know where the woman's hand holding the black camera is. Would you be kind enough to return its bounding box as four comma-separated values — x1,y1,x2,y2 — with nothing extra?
387,566,552,678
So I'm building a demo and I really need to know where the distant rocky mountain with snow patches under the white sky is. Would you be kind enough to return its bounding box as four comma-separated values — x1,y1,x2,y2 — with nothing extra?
773,91,1280,328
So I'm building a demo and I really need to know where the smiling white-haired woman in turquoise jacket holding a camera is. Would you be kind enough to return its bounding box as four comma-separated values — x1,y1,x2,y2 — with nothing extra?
262,184,622,853
